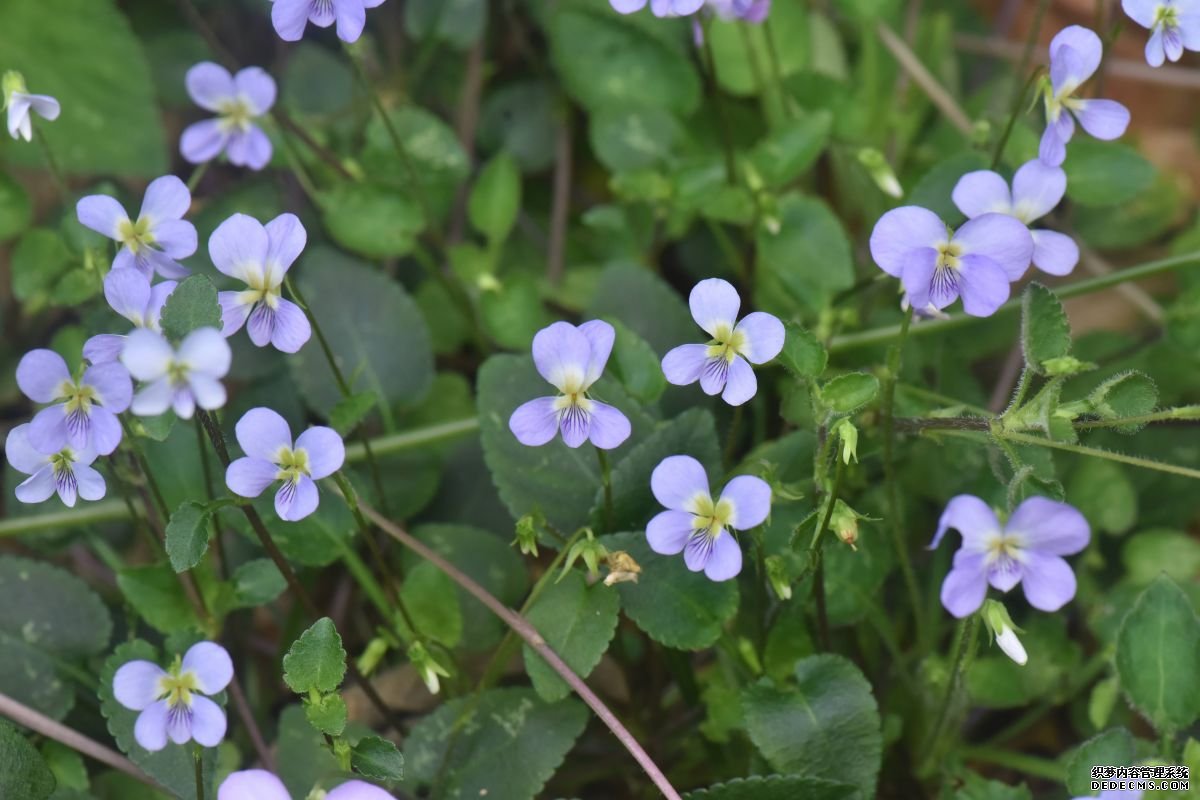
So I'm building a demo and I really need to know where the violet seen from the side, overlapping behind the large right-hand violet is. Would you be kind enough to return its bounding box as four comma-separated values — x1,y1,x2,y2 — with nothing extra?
952,160,1079,275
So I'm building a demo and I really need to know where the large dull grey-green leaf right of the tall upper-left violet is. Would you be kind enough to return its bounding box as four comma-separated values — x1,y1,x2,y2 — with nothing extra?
292,247,433,420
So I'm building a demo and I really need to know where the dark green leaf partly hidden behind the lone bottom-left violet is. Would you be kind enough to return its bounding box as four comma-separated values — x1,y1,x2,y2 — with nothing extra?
100,639,220,800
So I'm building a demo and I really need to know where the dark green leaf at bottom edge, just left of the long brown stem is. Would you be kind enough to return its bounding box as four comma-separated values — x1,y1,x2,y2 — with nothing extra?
404,688,588,800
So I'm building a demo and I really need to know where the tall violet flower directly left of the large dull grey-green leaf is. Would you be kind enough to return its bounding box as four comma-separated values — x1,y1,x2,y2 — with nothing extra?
209,213,312,353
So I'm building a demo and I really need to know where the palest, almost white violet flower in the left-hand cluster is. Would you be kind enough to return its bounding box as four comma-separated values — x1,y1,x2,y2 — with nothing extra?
121,327,233,420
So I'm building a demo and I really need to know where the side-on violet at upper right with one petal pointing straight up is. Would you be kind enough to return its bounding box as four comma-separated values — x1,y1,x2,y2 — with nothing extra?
1038,25,1129,167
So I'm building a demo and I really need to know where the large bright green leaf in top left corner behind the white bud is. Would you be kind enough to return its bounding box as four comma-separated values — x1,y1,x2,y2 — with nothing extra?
0,0,169,178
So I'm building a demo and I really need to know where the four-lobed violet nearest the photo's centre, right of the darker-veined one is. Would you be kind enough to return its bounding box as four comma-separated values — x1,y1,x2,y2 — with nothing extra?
662,278,785,405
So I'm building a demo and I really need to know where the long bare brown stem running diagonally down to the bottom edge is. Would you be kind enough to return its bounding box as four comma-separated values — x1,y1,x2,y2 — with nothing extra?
359,504,680,800
